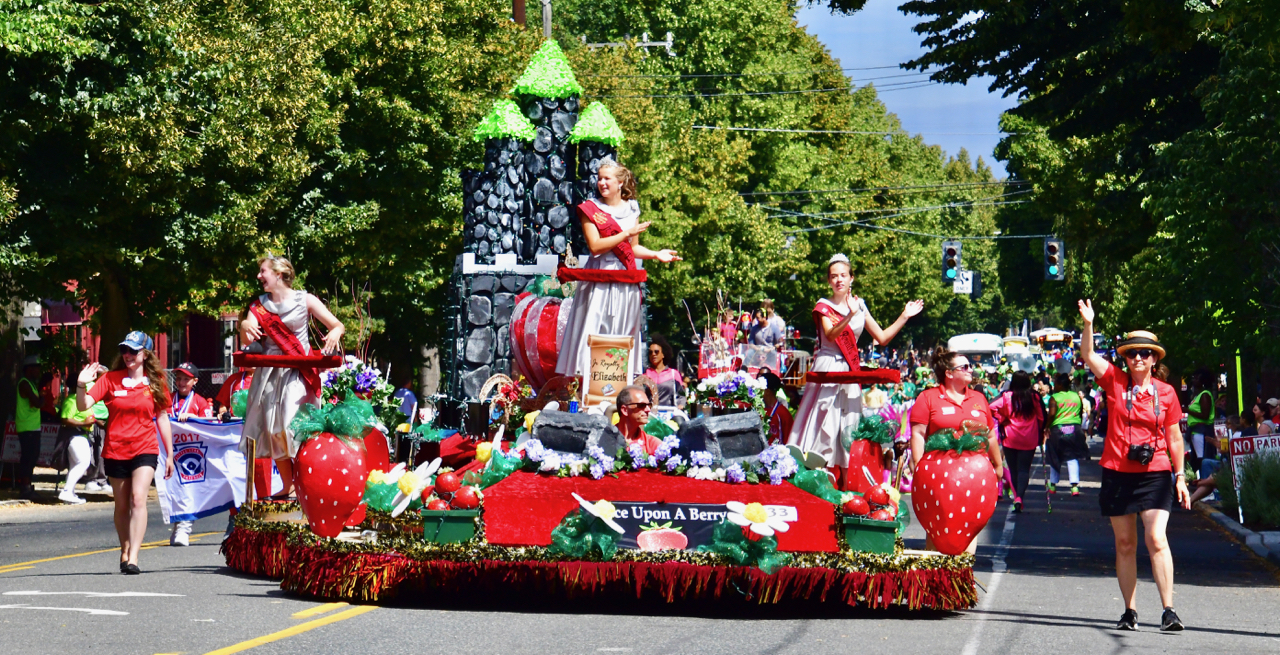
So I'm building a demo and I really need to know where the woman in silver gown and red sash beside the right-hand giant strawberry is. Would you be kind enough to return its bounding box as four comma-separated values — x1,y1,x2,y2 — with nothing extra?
787,255,924,489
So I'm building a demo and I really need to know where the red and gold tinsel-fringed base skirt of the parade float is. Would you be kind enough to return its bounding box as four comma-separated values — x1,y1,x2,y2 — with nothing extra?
223,513,978,610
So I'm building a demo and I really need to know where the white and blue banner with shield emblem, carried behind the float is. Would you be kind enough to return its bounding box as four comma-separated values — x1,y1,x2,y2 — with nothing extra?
156,418,246,523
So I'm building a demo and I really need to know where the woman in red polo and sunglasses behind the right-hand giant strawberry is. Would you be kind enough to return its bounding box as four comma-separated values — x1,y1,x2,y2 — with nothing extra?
910,347,1005,553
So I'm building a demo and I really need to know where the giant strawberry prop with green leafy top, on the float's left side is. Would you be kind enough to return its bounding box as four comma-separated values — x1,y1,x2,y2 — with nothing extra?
289,398,376,537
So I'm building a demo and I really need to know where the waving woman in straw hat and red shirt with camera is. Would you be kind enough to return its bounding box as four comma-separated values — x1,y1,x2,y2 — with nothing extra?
1079,301,1190,632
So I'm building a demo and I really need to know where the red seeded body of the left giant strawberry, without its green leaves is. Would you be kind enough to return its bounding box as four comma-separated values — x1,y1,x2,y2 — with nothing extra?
294,432,369,537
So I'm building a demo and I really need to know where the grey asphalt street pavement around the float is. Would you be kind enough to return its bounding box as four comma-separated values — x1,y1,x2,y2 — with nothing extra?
0,444,1280,655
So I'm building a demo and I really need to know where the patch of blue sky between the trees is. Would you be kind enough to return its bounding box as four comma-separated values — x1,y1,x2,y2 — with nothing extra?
796,0,1016,178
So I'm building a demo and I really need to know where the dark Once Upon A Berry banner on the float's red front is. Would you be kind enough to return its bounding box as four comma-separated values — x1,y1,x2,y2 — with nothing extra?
612,500,799,551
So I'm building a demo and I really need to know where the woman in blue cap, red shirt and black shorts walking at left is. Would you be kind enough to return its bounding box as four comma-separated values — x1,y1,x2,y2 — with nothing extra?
76,331,173,576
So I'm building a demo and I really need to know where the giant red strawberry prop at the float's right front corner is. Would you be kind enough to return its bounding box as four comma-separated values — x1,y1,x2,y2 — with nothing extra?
911,426,997,555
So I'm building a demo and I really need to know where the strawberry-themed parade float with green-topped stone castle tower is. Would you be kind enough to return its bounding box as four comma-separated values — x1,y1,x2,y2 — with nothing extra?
223,41,977,610
